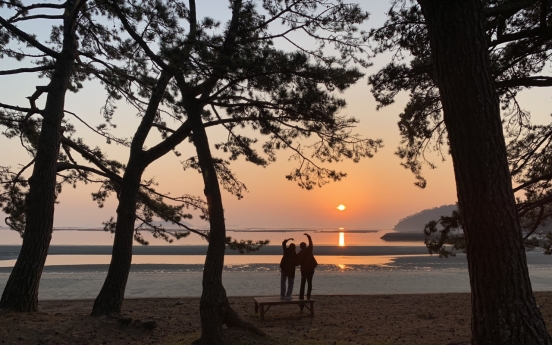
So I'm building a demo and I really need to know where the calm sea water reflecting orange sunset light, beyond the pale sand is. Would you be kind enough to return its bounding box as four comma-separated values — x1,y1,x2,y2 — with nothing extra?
0,228,425,268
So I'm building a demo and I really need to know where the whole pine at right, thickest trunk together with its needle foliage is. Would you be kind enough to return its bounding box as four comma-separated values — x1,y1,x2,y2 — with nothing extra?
370,0,552,344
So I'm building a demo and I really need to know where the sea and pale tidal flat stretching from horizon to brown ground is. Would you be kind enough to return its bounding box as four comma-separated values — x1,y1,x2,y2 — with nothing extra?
0,229,552,299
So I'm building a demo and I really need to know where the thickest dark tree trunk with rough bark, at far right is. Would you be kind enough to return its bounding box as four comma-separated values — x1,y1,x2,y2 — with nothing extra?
418,0,551,345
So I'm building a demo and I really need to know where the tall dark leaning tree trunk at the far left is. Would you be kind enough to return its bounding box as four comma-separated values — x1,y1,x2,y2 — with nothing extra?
0,0,86,312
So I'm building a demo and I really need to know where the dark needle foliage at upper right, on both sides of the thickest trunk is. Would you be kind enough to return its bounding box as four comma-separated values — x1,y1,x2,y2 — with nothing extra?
369,0,552,190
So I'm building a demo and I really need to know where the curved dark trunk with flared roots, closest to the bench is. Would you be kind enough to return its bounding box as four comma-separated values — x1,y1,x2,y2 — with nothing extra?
186,101,264,345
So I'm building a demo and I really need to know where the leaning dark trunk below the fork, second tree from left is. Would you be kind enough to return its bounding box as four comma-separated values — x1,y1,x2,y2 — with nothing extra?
92,163,145,316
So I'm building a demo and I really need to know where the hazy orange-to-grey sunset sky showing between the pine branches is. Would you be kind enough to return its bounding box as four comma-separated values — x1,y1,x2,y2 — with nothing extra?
0,0,550,229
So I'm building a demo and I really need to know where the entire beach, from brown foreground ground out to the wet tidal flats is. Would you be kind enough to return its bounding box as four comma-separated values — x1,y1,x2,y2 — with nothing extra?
0,242,552,345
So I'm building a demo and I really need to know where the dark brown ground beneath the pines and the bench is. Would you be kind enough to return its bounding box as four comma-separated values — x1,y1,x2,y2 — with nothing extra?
0,292,552,345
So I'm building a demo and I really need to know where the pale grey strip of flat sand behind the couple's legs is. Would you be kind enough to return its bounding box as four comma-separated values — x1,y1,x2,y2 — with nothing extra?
0,258,552,300
